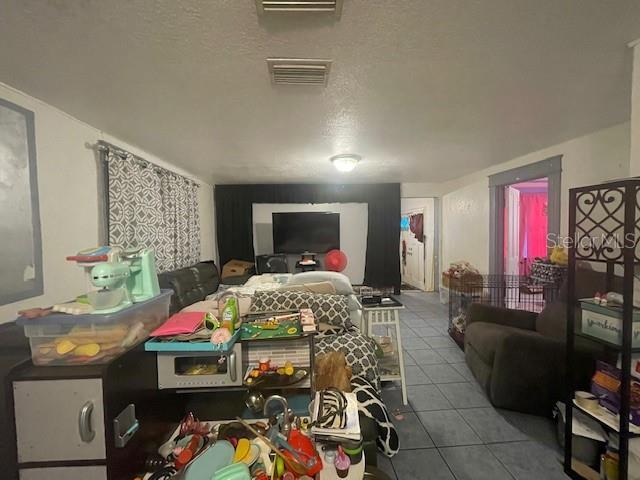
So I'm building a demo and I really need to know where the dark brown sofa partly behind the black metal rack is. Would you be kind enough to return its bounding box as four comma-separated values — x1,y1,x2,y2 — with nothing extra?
465,269,620,416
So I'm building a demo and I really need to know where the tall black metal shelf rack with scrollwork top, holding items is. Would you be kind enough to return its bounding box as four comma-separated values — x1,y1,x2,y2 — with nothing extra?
564,179,640,480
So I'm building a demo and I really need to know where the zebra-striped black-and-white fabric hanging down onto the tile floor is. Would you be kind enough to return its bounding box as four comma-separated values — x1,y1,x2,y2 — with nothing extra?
351,376,400,457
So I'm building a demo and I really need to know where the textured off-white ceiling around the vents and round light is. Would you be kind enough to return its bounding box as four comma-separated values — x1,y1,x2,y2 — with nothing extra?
0,0,640,183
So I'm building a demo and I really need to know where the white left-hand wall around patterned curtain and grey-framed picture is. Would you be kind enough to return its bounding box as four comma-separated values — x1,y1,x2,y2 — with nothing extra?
0,83,217,323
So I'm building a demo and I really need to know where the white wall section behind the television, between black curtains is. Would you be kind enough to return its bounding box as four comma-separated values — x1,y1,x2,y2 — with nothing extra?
253,203,369,285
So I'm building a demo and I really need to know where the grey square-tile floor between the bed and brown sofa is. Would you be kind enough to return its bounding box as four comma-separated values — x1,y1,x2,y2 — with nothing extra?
378,291,569,480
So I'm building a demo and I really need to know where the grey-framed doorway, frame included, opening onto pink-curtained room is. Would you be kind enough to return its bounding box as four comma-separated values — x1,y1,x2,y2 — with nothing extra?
489,155,562,276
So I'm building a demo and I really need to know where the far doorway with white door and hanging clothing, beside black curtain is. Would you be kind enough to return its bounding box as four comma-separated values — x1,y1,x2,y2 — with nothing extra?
400,198,436,292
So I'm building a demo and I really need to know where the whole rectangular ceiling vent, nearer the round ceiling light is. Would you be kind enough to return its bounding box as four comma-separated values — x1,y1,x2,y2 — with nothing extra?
267,58,331,86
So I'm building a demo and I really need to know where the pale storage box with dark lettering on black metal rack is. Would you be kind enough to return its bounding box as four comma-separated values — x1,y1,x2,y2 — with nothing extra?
580,300,640,348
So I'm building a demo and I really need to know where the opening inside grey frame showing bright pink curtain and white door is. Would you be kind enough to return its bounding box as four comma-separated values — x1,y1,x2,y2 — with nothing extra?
503,177,549,276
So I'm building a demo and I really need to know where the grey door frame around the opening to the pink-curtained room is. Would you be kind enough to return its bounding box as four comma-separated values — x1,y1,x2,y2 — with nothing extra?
489,155,562,274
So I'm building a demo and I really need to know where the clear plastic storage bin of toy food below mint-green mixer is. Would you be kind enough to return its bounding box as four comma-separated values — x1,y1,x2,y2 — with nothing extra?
16,290,173,365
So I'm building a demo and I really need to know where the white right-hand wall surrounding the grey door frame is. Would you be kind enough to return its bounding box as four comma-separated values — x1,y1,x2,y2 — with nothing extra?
440,123,630,273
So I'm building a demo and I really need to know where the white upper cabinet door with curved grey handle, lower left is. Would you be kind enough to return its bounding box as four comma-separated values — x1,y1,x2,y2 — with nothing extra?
13,378,106,463
